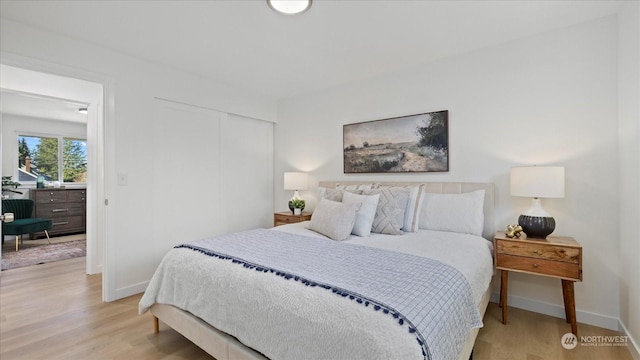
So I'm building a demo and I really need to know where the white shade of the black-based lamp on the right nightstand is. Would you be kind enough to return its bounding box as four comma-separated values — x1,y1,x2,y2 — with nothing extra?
510,166,564,198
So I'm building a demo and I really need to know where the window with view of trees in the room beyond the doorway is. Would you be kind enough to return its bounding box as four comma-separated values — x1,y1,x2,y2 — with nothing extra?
18,135,87,183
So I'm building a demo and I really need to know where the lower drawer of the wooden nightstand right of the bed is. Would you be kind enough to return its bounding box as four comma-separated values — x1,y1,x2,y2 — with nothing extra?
496,254,581,280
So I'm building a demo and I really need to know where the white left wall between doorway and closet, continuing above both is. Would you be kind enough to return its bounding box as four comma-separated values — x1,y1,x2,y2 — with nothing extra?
0,19,277,300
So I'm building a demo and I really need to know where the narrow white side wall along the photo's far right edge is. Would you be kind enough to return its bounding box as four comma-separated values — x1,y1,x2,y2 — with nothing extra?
618,1,640,359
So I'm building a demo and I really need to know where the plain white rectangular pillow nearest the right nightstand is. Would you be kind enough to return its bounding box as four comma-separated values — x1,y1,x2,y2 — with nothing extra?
420,190,484,236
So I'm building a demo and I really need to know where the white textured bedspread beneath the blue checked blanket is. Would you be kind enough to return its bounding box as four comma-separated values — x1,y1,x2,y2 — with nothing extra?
139,223,493,360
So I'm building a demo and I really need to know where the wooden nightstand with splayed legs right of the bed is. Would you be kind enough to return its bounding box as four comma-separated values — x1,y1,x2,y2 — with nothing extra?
493,232,582,336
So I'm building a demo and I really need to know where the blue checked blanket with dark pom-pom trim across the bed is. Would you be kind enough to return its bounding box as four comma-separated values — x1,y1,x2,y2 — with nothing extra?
177,229,482,359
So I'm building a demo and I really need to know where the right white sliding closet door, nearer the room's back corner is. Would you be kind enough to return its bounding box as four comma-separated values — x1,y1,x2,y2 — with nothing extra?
220,114,273,232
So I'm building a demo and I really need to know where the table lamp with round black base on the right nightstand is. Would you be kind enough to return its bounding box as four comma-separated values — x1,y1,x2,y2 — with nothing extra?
510,166,564,239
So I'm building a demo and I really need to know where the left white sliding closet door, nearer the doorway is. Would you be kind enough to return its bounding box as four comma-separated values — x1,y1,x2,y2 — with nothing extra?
153,100,227,245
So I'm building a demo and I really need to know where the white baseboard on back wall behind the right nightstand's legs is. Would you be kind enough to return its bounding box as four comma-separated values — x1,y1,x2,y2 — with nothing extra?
491,293,621,331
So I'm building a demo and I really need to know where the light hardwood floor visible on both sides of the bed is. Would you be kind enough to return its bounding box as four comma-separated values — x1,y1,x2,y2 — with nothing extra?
0,258,632,360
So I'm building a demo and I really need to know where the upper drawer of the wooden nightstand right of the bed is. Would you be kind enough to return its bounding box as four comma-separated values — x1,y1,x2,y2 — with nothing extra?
497,241,580,264
